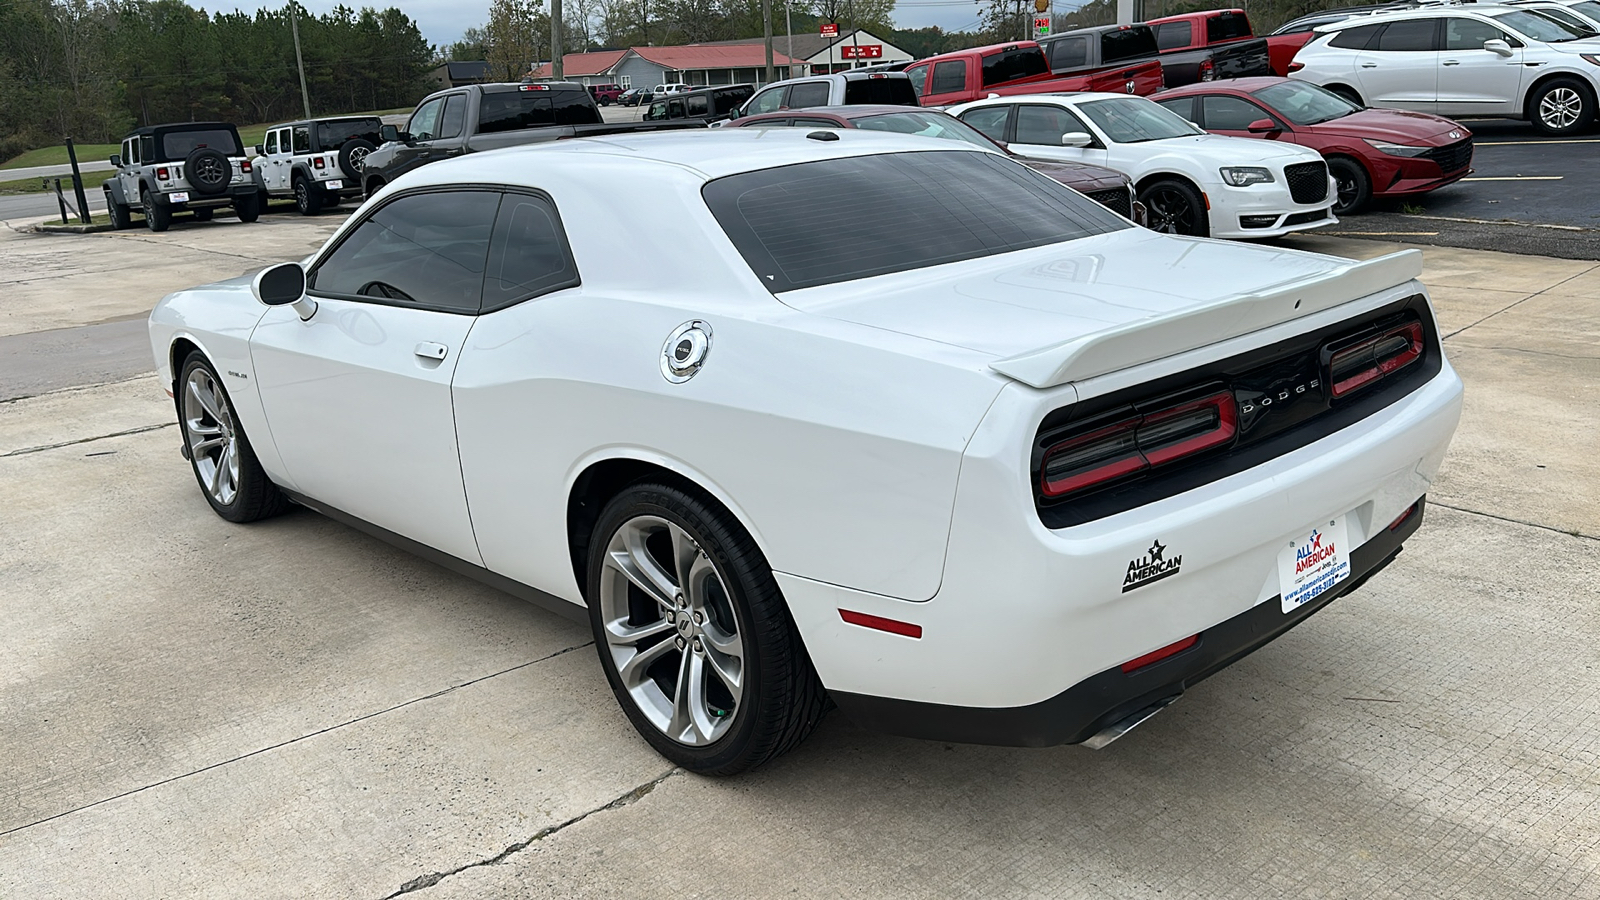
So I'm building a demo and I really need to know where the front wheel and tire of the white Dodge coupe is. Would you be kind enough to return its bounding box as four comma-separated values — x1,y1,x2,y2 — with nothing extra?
178,351,288,522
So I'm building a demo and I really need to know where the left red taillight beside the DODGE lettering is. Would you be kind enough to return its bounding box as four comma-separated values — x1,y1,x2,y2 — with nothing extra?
1040,391,1238,500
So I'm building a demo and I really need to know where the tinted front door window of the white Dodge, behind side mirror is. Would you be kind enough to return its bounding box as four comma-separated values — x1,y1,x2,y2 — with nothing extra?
307,191,501,314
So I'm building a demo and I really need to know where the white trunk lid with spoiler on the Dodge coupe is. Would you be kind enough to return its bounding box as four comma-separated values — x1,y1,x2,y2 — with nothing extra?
779,227,1421,386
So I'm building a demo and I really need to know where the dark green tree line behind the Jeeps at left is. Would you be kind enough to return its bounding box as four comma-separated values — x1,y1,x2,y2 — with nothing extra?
0,0,435,160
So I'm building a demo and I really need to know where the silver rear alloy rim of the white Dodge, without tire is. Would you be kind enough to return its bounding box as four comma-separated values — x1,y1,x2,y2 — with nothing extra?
597,516,746,746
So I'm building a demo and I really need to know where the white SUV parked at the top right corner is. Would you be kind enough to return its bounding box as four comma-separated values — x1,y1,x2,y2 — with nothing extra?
1290,5,1600,135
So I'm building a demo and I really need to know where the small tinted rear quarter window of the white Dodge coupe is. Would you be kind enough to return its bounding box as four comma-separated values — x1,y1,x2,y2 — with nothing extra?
483,194,579,312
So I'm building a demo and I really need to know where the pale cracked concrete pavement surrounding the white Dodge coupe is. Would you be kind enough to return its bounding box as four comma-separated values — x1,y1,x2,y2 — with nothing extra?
0,199,1600,900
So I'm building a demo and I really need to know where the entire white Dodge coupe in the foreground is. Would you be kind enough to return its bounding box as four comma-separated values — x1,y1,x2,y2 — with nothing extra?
150,128,1461,773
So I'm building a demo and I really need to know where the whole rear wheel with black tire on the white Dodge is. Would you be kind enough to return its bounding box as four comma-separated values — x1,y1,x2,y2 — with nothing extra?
587,484,827,775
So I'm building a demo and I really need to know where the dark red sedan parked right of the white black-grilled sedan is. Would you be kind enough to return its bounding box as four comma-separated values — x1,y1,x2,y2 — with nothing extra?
1150,78,1472,216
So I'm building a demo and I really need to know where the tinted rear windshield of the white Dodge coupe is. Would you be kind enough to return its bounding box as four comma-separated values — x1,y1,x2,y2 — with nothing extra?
702,151,1131,293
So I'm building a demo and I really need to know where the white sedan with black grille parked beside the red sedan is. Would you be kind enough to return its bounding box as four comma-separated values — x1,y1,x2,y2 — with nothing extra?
950,93,1338,237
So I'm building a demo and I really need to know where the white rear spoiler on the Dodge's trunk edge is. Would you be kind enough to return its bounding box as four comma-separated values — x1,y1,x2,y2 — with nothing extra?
989,250,1422,388
